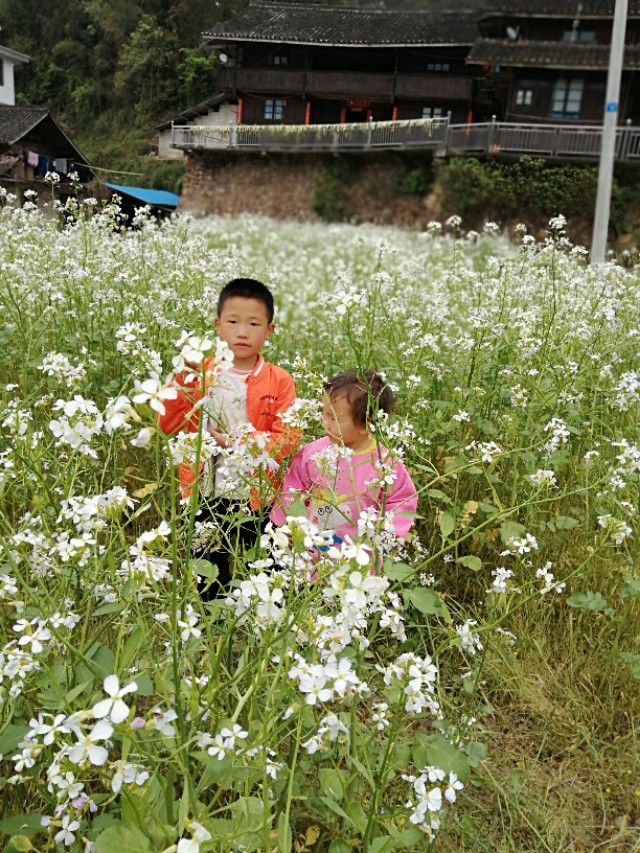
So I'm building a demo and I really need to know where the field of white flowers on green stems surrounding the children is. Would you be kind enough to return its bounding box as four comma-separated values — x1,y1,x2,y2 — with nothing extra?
0,188,640,853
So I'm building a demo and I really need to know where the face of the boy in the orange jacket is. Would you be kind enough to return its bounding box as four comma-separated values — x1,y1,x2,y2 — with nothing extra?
214,296,274,370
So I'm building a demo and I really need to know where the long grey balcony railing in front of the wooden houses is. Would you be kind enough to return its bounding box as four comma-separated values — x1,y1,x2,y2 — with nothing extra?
171,118,640,161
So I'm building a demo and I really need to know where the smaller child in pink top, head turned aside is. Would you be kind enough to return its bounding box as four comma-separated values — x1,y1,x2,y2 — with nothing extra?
271,370,418,556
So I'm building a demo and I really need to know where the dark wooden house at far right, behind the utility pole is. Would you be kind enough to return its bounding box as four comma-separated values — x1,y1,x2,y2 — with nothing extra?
467,0,640,125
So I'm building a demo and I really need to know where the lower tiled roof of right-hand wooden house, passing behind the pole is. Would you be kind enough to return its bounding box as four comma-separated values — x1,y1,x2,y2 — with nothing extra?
467,39,640,70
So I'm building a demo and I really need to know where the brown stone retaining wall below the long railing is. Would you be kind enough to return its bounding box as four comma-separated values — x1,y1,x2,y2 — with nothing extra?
179,151,434,228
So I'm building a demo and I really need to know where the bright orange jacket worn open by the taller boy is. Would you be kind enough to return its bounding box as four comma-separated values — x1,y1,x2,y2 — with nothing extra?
158,355,300,509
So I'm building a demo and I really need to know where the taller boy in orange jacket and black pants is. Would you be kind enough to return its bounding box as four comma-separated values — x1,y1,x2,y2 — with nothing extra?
158,278,299,597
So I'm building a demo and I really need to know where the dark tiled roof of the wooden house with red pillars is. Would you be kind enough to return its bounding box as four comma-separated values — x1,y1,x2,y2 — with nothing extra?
203,0,478,47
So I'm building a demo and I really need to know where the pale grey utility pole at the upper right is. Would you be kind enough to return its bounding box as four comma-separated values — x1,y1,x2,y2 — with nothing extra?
591,0,628,264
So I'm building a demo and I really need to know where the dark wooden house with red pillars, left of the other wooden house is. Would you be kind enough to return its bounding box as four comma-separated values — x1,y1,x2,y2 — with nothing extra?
203,0,478,125
